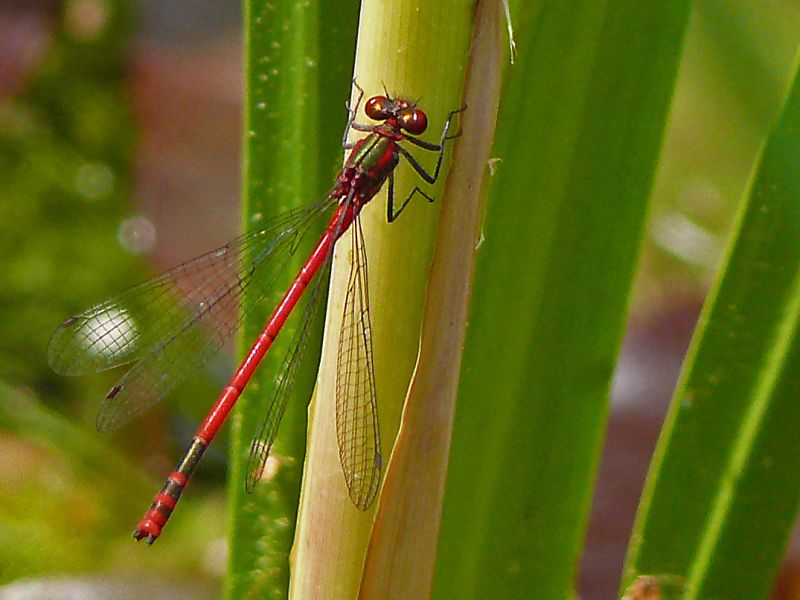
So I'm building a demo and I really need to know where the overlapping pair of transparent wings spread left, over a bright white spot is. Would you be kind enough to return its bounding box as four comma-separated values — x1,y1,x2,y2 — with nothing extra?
48,198,335,431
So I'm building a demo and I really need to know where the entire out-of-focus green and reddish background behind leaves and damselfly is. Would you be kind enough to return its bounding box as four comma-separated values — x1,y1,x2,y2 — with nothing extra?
0,0,800,599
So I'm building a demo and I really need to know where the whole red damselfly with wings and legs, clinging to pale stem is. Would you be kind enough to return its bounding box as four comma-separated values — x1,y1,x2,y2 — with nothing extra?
48,86,464,544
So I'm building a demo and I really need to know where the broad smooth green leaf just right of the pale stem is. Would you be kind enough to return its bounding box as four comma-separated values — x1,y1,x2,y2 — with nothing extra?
434,0,689,599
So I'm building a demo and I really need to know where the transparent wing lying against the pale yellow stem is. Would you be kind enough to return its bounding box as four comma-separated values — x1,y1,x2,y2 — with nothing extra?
336,218,381,510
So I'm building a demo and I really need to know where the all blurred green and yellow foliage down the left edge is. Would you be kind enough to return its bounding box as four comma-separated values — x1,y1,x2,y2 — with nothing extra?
0,0,221,583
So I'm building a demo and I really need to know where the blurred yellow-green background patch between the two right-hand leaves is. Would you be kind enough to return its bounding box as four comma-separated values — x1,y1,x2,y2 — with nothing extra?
633,0,800,312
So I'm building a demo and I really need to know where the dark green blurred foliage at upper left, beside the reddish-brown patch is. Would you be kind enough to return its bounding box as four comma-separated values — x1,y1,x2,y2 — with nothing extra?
0,3,138,399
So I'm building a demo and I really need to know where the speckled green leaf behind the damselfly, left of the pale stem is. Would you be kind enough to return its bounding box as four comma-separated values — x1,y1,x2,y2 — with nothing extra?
226,0,357,598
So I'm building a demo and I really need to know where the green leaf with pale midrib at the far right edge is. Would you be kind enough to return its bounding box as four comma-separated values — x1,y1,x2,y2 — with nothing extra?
625,50,800,599
